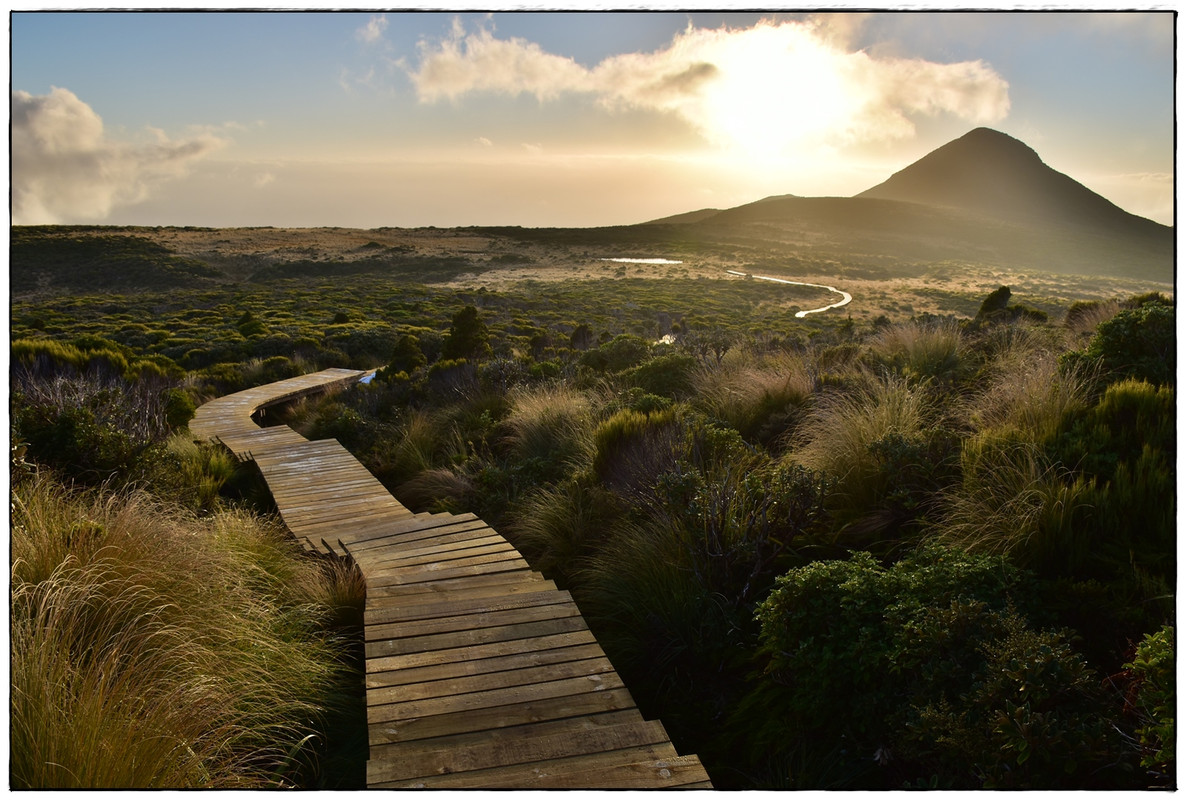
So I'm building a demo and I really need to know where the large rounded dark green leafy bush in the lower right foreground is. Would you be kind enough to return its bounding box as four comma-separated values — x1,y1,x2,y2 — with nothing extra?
739,546,1112,788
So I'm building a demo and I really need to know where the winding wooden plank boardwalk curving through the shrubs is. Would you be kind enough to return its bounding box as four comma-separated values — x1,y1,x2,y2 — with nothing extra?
190,370,712,789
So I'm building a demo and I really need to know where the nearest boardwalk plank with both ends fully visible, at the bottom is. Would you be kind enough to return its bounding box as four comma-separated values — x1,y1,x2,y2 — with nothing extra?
366,717,668,782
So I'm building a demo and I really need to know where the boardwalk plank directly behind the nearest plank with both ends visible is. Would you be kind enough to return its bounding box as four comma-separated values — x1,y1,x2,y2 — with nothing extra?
368,689,645,757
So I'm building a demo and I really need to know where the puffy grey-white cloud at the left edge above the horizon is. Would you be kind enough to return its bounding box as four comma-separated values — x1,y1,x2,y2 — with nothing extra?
12,88,225,224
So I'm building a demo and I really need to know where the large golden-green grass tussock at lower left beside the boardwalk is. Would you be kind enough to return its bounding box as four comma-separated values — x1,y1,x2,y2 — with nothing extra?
11,478,361,788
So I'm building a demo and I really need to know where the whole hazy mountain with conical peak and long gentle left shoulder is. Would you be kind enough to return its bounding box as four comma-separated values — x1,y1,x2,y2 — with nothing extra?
649,128,1174,283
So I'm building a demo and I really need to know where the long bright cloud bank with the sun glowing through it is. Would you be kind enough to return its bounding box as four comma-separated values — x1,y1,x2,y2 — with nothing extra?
404,17,1009,151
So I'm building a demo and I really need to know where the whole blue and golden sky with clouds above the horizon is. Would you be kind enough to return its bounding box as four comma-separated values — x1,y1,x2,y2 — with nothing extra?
9,6,1175,228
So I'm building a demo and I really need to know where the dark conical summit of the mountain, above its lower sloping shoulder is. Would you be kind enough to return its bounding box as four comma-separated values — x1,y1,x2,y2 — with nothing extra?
856,128,1166,235
